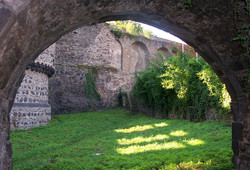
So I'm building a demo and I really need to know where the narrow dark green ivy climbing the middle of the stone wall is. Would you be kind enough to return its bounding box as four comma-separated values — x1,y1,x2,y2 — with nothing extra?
83,69,100,111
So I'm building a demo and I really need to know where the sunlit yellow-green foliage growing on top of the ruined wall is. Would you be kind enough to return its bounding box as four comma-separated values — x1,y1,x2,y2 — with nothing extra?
109,21,153,38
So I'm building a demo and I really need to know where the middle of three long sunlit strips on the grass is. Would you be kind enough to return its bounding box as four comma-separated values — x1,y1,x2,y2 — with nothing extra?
117,135,169,145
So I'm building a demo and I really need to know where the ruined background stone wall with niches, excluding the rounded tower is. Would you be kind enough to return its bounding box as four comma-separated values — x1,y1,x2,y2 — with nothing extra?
49,24,194,114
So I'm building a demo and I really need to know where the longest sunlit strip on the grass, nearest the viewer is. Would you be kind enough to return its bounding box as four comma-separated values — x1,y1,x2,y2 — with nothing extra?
116,142,185,154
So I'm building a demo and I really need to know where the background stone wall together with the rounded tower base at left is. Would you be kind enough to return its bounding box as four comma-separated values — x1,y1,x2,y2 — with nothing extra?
10,24,197,124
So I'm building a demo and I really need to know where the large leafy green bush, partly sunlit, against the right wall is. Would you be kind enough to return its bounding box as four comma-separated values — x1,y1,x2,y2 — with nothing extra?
133,52,231,121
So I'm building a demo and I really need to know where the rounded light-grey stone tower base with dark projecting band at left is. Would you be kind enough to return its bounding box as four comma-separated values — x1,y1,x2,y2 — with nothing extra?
10,44,55,129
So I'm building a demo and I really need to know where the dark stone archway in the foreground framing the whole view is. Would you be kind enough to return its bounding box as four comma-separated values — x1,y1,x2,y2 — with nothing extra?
0,0,250,169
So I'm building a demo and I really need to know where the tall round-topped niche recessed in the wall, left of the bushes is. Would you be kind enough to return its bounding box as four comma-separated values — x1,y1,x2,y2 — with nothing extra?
132,41,149,71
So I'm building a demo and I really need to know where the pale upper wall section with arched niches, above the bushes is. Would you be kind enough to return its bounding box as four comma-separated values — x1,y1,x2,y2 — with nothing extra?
119,34,191,73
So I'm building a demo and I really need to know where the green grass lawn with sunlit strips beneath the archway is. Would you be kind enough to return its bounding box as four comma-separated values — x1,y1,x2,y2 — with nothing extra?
11,109,234,170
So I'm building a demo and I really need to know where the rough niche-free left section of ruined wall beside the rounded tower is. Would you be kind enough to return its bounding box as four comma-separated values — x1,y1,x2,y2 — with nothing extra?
49,24,121,114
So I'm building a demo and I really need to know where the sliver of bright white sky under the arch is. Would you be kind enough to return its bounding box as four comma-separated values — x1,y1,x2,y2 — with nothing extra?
140,23,186,44
